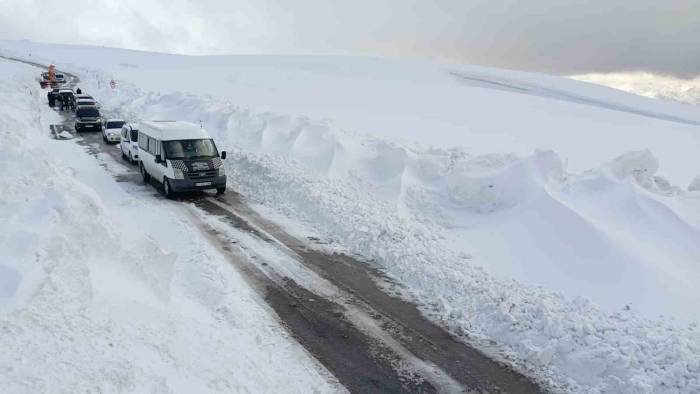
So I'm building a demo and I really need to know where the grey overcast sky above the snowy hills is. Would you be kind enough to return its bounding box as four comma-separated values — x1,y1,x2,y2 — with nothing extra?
0,0,700,77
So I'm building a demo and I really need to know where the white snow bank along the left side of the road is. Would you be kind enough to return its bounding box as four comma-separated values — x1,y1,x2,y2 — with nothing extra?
0,60,342,393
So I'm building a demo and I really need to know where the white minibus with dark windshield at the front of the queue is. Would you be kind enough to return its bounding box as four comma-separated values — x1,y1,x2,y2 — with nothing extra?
138,121,226,197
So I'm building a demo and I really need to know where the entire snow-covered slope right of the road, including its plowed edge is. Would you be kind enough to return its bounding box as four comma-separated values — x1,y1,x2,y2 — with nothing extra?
0,42,700,393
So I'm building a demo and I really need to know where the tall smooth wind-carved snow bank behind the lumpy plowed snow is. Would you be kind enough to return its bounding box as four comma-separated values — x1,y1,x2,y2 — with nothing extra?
105,86,700,321
